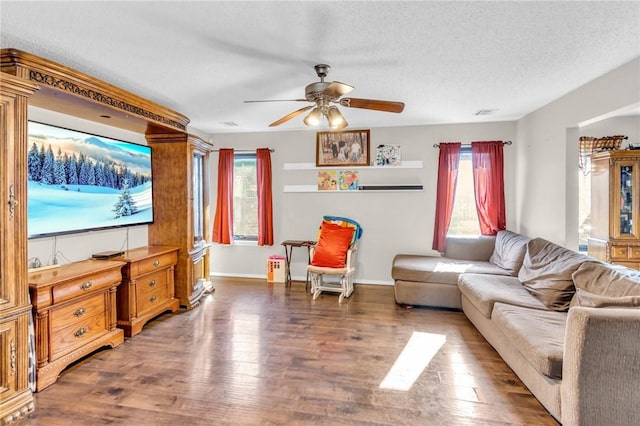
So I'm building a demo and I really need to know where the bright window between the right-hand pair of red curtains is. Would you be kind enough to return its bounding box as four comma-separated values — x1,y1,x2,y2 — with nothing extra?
447,146,480,236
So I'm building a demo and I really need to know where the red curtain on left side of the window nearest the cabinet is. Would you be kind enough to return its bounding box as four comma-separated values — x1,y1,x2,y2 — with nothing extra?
213,148,233,244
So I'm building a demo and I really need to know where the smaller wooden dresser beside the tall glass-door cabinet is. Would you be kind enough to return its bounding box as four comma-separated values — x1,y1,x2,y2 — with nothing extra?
113,246,180,337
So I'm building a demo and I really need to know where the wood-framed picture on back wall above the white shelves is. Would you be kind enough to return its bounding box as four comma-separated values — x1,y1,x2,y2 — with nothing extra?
316,130,370,167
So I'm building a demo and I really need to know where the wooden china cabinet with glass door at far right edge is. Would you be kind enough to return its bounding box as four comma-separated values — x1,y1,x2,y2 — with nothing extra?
588,150,640,270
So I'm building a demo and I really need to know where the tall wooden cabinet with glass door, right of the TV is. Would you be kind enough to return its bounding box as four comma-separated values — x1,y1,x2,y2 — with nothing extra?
146,134,213,309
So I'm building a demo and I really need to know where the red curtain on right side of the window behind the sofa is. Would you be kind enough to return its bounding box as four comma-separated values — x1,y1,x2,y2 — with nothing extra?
471,141,506,235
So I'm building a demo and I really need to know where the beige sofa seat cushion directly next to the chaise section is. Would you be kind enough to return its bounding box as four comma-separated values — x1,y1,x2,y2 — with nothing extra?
458,274,546,318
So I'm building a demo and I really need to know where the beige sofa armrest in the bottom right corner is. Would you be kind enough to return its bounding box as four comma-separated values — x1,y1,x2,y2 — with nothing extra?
561,307,640,425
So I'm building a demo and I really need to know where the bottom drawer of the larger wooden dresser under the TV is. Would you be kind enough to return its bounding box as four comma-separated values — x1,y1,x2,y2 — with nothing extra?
49,313,107,361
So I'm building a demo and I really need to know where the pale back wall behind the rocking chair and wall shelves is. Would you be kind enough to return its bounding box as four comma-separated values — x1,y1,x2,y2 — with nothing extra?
211,122,518,284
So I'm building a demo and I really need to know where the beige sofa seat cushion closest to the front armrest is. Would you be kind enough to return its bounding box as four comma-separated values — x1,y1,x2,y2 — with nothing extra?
491,303,567,379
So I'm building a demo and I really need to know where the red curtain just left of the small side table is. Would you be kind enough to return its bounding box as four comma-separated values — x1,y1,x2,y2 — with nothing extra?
256,148,273,246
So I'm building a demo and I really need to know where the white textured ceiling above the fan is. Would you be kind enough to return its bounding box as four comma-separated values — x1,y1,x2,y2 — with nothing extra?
0,0,640,134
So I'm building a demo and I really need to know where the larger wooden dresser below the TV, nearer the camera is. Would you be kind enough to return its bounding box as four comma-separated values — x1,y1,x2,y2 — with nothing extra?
29,260,125,392
